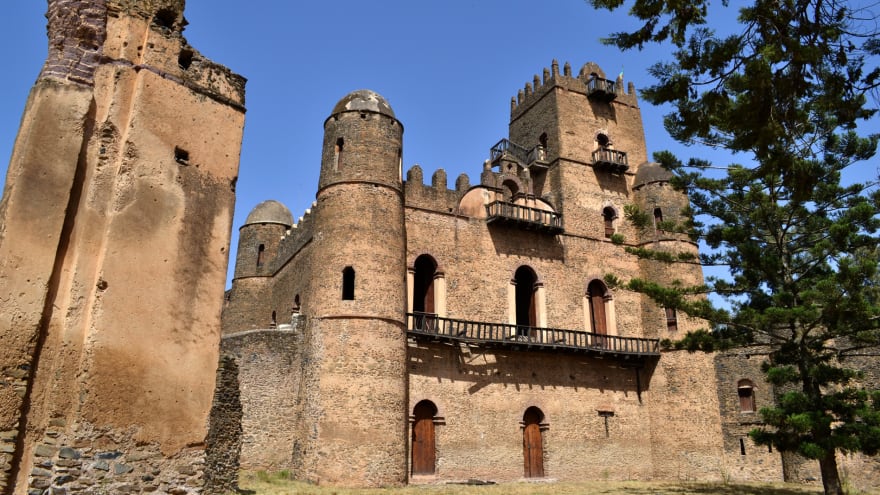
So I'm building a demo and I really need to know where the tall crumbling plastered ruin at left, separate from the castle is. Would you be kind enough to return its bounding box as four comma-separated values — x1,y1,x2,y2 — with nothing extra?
0,0,244,494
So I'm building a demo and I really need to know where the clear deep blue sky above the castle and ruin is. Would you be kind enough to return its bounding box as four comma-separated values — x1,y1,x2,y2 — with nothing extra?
0,0,872,285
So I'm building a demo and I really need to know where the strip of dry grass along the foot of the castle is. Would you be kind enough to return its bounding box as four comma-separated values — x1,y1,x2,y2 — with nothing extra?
234,471,844,495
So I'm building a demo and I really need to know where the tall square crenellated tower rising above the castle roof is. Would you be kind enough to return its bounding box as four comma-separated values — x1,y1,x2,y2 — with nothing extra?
510,61,647,239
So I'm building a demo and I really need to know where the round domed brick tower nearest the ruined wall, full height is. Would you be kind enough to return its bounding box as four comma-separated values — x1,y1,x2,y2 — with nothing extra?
294,90,408,486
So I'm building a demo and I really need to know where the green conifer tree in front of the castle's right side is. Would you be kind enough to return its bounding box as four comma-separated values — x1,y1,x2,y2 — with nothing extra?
590,0,880,493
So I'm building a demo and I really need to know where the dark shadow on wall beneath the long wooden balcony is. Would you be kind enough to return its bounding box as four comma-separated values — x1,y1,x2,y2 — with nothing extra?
407,343,656,397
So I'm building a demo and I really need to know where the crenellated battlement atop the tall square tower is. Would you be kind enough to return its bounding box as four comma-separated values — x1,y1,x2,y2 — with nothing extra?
510,59,636,121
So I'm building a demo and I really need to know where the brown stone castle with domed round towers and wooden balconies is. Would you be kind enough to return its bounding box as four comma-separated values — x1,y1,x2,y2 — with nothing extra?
221,62,740,486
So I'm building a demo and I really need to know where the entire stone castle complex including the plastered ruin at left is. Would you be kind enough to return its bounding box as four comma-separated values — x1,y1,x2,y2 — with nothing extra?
0,0,880,495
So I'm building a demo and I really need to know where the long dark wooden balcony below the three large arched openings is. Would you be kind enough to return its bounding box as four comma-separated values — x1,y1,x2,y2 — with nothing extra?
406,313,660,359
